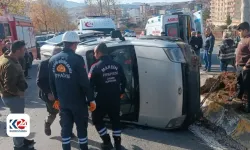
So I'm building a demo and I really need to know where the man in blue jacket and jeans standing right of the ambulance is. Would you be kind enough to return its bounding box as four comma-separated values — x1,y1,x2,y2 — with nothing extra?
203,28,215,72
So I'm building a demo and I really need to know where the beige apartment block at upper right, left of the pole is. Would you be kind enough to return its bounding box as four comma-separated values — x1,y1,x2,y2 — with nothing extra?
210,0,241,26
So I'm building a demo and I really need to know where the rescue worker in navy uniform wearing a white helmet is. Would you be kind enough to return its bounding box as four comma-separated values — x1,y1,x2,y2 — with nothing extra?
49,31,96,150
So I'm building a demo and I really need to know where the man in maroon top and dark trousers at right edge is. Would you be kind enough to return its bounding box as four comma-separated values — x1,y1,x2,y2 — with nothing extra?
229,22,250,113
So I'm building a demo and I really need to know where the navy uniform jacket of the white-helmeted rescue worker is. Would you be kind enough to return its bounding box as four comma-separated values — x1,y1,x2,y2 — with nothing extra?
49,48,94,110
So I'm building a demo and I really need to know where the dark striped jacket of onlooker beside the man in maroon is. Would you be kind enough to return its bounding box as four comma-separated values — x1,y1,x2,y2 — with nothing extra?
218,39,235,60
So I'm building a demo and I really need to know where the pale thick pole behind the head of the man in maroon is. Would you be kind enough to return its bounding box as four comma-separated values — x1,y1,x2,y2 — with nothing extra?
241,0,250,23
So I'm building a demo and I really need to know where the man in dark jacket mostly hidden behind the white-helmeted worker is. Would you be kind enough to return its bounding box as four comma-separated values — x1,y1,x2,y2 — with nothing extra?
36,48,75,138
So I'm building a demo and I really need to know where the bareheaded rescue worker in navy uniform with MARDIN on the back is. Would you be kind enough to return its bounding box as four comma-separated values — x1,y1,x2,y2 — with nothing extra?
89,43,126,150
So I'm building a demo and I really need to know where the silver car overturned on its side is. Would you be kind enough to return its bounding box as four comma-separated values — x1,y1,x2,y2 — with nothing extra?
76,31,200,129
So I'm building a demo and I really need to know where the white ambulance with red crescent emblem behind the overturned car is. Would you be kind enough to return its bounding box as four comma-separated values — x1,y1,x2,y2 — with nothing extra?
78,17,116,34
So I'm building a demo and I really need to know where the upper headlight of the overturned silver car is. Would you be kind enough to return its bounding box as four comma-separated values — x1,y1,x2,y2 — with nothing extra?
163,47,186,63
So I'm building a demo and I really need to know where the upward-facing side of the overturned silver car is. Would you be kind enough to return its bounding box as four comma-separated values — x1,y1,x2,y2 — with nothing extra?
76,37,182,55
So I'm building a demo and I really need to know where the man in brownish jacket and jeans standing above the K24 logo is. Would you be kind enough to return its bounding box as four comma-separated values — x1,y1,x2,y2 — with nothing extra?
0,41,34,150
